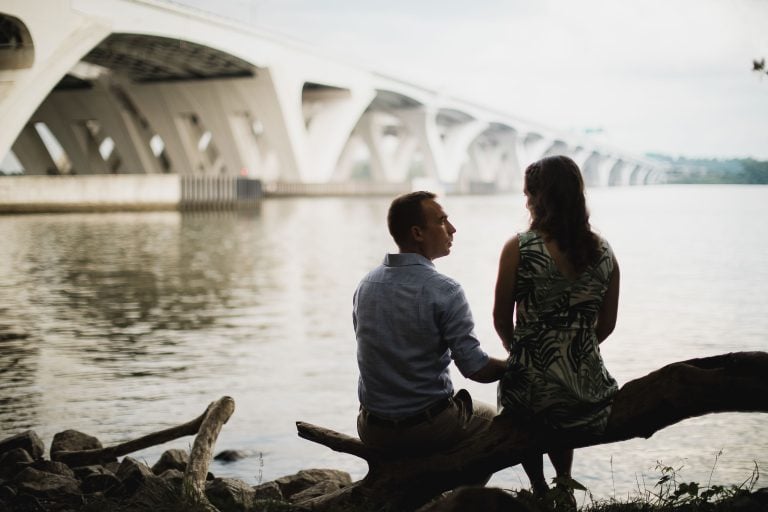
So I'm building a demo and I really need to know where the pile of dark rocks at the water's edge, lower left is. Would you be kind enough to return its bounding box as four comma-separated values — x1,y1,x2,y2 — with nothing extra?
0,430,352,512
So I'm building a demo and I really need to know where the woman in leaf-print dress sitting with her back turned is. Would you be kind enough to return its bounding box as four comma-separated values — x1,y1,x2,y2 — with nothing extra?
493,156,619,496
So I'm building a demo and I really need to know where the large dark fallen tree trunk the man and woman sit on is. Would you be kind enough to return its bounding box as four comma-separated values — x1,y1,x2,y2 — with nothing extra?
297,352,768,511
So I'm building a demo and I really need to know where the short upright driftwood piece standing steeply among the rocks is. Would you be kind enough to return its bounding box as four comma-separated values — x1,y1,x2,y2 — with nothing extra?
182,396,235,512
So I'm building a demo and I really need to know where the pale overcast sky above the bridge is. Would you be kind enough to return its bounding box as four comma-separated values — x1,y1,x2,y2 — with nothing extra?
175,0,768,160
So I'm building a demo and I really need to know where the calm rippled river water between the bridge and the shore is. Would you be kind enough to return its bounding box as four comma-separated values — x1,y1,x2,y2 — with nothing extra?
0,186,768,499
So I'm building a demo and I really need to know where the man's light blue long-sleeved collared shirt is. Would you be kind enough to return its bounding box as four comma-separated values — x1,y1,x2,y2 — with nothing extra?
352,253,489,418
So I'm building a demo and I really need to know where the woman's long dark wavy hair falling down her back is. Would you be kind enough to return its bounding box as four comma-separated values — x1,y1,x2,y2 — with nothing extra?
525,156,600,272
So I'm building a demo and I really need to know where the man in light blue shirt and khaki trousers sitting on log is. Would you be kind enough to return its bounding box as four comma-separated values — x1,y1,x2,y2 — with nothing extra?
353,192,504,453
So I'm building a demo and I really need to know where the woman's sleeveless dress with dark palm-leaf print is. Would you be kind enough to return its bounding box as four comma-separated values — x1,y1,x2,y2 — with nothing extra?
498,231,618,432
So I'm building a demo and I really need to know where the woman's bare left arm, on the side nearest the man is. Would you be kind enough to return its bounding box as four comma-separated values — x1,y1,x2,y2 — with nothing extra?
493,235,520,352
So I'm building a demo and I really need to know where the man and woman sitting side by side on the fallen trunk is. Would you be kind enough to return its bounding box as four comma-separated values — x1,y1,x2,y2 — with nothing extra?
353,156,619,504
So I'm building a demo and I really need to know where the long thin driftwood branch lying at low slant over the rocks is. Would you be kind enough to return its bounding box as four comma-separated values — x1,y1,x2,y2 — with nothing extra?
51,397,232,467
